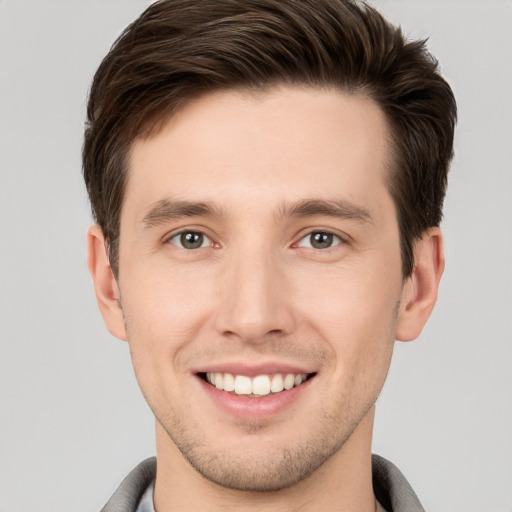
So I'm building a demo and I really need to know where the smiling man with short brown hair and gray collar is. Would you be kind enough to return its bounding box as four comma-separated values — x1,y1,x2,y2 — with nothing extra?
83,0,456,512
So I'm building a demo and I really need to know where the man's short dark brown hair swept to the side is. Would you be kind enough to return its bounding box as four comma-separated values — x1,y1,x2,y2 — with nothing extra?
83,0,456,277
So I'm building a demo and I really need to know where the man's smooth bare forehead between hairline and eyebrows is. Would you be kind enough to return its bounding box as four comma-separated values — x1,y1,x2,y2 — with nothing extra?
123,87,389,222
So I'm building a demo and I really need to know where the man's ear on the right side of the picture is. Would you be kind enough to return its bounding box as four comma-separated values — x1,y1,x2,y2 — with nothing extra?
395,228,444,341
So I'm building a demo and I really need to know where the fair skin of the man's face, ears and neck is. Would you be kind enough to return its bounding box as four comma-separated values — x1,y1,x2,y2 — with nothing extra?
88,87,444,512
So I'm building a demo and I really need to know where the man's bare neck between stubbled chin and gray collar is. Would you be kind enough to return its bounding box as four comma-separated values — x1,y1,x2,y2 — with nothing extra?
154,407,375,512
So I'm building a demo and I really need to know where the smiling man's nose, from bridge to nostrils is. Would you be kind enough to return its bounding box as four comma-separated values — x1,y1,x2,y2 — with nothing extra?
216,244,295,344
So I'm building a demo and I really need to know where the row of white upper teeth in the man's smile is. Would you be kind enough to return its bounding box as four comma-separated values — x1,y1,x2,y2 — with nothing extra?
206,373,307,396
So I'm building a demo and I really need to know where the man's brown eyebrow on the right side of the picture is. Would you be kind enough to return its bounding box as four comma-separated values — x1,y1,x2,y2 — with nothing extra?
279,199,373,224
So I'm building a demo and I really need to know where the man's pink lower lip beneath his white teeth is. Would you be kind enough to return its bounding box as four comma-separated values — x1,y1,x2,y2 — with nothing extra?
197,376,314,420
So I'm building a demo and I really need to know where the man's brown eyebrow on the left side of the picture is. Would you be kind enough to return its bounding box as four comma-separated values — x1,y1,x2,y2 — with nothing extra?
142,199,225,227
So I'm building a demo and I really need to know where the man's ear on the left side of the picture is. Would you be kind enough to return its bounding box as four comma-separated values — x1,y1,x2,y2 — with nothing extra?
87,225,127,341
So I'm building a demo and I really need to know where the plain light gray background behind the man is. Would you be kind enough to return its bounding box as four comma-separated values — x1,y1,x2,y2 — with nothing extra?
0,0,512,512
